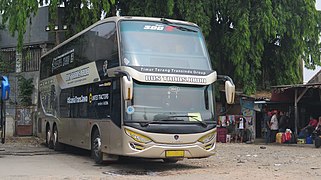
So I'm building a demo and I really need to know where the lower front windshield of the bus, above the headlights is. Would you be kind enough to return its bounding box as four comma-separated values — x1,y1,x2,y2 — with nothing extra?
125,82,214,123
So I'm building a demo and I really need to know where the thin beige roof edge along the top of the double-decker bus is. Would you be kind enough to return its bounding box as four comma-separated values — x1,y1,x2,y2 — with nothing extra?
41,16,198,58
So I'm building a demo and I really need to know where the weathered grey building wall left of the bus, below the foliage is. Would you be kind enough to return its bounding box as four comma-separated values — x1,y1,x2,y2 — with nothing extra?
0,7,64,137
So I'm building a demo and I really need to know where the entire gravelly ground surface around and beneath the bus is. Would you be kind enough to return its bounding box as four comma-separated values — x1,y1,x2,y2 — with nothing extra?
0,137,321,180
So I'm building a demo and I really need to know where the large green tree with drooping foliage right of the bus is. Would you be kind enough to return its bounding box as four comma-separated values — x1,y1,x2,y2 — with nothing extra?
174,0,321,94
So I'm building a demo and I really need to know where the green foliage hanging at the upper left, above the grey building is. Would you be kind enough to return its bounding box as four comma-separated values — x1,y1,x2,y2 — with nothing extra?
0,0,115,52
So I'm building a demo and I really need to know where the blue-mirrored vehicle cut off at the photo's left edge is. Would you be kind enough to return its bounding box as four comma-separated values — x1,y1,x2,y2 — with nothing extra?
0,75,10,144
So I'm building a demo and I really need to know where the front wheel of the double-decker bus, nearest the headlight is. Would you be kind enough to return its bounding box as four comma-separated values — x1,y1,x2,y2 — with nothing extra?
91,129,103,164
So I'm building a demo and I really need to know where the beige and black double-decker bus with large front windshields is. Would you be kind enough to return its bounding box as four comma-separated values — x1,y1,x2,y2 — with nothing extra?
38,17,235,163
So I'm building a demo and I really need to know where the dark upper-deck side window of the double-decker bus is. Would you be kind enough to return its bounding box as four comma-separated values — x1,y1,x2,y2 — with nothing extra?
40,23,119,79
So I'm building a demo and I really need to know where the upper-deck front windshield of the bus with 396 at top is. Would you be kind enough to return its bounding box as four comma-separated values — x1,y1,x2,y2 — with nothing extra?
120,21,211,70
